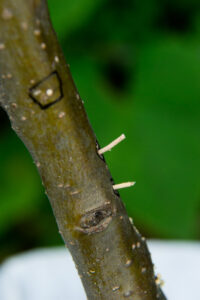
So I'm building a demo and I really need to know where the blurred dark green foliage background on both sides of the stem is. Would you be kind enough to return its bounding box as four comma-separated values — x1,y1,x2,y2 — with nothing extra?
0,0,200,260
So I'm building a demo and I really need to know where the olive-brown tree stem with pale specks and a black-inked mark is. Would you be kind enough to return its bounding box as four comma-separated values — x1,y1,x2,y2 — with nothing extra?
0,0,165,300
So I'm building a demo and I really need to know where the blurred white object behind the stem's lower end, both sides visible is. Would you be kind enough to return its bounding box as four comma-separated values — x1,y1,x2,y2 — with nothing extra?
0,241,200,300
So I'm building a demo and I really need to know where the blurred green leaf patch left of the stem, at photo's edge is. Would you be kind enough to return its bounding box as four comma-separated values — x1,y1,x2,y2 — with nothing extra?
0,130,42,234
